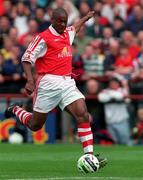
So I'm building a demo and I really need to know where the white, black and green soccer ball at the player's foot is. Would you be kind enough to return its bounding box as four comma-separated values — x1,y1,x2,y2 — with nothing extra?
77,154,99,173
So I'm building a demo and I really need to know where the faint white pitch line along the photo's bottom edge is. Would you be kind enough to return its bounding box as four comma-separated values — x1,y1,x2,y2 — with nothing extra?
7,176,143,180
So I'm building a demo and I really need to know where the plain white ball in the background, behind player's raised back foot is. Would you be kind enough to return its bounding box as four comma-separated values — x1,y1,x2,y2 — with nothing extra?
8,132,23,144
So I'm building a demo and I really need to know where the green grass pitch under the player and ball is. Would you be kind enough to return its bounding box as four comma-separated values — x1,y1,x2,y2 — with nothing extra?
0,143,143,180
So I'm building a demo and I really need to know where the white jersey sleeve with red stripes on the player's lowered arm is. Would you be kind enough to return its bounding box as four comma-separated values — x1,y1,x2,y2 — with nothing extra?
22,35,47,64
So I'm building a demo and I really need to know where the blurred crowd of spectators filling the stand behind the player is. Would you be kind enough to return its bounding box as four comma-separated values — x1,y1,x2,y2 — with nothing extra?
0,0,143,144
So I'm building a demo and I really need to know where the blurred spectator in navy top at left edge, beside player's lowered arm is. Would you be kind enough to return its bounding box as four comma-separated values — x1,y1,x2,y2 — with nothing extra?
0,45,24,93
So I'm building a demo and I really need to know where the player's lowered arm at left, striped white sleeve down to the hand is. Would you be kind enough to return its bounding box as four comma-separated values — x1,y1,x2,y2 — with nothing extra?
22,35,47,95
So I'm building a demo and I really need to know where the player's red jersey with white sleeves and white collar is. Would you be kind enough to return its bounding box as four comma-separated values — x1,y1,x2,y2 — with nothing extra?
22,26,75,75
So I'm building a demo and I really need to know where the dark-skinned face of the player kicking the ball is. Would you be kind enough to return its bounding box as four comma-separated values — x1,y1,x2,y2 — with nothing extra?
52,15,68,34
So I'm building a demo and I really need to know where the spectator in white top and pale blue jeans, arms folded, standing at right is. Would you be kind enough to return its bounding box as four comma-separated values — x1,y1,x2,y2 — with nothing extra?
98,74,130,145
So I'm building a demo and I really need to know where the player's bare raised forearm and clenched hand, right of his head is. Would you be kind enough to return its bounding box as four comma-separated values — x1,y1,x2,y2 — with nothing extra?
73,11,95,33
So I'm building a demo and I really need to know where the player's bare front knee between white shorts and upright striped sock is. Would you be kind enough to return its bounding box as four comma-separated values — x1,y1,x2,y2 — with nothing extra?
65,98,87,118
